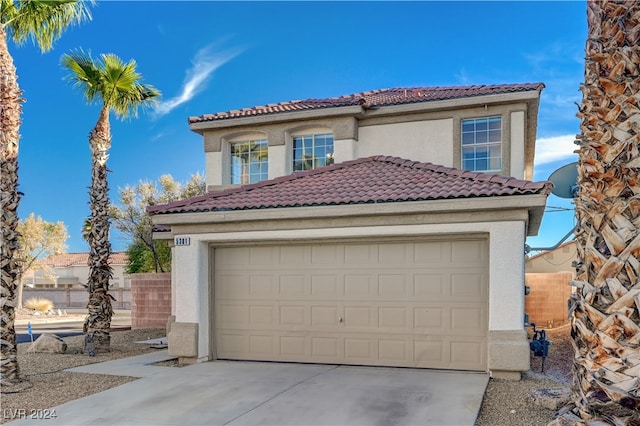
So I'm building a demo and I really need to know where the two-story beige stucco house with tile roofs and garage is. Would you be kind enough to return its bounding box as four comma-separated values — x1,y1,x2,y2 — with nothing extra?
148,83,551,378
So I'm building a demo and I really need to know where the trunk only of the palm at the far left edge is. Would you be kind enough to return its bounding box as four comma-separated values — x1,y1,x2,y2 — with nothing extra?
0,26,22,386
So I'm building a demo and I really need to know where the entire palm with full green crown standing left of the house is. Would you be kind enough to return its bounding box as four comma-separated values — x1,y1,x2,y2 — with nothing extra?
61,51,160,355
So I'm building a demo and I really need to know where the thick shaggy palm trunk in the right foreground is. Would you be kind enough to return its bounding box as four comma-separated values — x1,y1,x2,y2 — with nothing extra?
555,0,640,425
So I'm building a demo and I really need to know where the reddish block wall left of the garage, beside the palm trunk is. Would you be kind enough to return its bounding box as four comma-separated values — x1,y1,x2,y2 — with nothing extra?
131,273,171,330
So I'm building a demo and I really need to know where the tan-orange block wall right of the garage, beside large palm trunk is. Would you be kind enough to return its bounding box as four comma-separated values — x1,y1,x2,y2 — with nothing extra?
524,272,573,328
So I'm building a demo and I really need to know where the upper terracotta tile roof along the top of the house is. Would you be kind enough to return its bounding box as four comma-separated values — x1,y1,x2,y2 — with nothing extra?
189,83,544,124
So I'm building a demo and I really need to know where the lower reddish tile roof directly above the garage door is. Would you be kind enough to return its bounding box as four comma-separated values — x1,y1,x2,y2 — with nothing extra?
147,156,553,214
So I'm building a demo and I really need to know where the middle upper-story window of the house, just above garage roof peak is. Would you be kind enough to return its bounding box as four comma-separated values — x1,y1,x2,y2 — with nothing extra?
293,133,333,172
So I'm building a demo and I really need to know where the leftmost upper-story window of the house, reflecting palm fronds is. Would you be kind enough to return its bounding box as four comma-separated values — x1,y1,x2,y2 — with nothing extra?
231,139,269,185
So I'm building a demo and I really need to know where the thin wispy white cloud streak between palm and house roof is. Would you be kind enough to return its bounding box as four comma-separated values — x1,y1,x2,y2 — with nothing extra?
154,45,243,116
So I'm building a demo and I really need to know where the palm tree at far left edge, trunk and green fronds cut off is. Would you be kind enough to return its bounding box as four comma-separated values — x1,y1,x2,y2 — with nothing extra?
0,0,93,386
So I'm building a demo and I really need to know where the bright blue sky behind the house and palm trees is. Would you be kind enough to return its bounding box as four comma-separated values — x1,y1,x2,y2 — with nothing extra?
9,1,587,252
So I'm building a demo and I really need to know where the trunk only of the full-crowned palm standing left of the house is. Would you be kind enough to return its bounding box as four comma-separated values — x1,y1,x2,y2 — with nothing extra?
84,108,113,355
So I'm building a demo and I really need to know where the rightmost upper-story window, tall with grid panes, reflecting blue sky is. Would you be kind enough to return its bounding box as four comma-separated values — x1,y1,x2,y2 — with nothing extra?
462,117,502,173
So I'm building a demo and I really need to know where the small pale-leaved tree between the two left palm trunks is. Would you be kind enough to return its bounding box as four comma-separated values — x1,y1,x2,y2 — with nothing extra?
16,213,69,309
